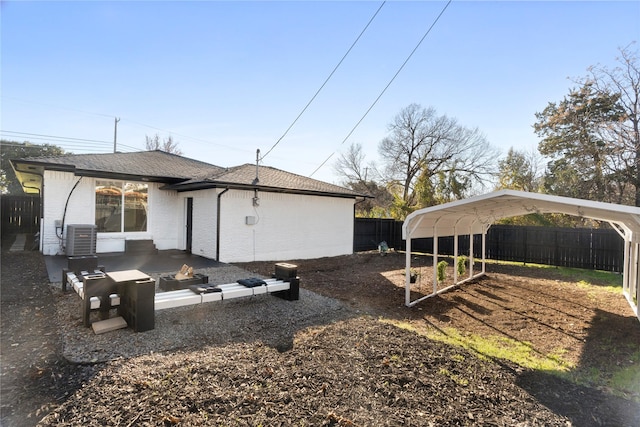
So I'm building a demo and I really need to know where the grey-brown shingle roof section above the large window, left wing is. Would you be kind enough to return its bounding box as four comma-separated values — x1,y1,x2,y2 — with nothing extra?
13,150,224,180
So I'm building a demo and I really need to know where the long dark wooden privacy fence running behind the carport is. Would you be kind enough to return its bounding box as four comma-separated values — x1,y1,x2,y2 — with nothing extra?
354,218,624,272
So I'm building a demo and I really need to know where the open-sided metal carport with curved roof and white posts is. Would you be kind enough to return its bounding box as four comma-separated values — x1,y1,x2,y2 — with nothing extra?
402,190,640,320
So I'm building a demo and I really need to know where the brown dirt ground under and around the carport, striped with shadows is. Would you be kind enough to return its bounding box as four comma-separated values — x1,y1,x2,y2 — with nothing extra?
238,252,640,374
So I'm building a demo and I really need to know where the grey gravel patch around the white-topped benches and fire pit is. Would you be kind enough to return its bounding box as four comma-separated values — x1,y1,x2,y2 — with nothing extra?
54,266,353,363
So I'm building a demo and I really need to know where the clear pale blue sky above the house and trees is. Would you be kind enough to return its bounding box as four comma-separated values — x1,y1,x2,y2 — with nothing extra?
0,1,640,183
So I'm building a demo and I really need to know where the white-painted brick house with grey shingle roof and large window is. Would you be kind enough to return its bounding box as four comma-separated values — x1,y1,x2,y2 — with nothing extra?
11,151,364,262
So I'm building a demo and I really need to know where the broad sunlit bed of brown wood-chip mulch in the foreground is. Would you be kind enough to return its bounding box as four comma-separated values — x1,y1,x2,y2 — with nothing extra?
43,317,566,426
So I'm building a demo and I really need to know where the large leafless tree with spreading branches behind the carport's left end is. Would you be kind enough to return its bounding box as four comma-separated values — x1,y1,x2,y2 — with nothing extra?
378,104,497,213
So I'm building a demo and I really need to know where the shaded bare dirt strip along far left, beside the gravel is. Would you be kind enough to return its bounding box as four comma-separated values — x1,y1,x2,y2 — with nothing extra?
0,250,98,426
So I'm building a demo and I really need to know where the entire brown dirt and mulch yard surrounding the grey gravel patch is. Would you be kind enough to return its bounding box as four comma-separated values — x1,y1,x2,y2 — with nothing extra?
2,246,640,426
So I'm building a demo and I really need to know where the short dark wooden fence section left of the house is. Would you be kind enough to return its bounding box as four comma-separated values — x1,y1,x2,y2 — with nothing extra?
0,195,40,234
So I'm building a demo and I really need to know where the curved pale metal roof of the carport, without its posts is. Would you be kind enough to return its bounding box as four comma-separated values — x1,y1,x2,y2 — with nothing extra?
402,190,640,239
